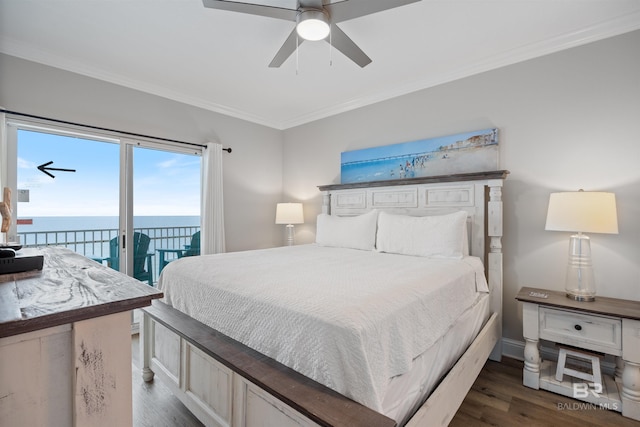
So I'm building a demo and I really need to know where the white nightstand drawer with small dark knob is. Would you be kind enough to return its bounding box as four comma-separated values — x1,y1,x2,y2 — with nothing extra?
539,307,622,356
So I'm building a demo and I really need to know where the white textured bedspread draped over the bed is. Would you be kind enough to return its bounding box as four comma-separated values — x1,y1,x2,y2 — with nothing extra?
159,244,488,412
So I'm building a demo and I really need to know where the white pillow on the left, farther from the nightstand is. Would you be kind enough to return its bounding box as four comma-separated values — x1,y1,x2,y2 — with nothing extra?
316,210,378,251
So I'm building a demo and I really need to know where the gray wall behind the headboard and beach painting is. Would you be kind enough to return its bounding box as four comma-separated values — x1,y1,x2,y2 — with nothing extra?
283,31,640,352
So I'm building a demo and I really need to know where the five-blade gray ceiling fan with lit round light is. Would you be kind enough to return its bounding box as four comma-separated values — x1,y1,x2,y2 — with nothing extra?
202,0,420,67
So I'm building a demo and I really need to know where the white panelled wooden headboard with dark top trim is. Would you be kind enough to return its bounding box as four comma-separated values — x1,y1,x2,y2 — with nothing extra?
318,170,509,362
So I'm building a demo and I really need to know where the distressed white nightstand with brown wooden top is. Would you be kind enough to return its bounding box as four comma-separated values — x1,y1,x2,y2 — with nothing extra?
516,288,640,420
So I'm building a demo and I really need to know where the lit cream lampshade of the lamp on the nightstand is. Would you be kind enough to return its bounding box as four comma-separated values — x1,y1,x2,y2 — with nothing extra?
545,191,618,234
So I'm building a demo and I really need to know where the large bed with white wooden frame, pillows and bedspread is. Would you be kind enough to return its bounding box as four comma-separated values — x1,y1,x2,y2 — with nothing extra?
141,171,508,426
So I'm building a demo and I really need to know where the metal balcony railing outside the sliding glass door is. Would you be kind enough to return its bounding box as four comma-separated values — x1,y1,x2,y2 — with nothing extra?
18,226,200,283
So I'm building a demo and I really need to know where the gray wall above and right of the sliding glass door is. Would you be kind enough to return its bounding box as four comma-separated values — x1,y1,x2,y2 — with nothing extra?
0,55,283,251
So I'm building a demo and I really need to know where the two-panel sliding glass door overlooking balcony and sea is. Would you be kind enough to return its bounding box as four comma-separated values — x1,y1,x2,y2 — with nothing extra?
8,122,201,286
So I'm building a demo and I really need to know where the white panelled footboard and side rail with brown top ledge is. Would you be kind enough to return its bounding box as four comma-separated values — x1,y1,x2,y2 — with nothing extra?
140,302,499,427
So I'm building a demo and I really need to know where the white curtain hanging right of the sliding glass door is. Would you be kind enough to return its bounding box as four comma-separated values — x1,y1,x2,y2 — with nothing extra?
200,142,225,255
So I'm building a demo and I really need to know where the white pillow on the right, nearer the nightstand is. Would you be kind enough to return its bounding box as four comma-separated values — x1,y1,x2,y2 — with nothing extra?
376,211,467,259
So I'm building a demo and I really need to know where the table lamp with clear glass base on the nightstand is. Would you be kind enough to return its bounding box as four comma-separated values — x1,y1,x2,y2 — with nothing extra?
545,190,618,301
